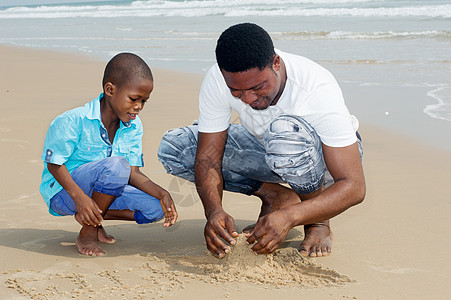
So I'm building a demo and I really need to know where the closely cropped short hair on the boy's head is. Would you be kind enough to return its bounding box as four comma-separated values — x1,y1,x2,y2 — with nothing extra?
102,52,153,87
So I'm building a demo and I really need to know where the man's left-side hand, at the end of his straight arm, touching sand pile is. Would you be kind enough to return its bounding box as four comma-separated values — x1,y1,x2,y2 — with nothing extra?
204,210,238,258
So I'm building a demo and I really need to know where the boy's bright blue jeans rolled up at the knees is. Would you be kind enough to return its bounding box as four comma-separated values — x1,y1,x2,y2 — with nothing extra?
50,156,164,224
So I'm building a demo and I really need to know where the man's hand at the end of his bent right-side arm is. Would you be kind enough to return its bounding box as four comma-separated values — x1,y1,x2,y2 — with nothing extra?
247,209,292,254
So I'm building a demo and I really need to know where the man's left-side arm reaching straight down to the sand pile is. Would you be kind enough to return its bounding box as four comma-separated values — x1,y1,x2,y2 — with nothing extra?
194,130,242,258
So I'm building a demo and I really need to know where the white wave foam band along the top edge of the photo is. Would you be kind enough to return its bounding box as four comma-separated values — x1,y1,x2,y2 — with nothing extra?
0,0,451,19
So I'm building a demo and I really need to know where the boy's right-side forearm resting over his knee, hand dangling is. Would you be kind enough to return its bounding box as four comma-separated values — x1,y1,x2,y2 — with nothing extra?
129,166,178,227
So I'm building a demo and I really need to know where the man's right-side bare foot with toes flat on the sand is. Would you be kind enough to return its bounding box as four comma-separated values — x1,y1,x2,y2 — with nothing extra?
299,221,332,257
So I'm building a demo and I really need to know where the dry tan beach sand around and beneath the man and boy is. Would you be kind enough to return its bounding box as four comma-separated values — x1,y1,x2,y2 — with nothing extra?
0,46,451,299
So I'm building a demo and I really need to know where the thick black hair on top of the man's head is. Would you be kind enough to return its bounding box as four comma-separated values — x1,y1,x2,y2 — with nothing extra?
216,23,276,73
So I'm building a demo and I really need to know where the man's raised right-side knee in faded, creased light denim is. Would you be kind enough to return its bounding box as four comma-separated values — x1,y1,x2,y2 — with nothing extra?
264,115,326,194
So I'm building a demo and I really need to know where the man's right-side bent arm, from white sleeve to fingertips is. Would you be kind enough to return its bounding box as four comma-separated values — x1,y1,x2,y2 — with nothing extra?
247,143,366,253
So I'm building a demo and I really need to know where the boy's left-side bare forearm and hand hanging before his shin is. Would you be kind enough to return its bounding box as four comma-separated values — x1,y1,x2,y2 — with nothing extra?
47,163,103,227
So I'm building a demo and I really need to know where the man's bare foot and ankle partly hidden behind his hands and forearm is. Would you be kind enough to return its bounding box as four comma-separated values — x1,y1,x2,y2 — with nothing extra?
243,182,300,233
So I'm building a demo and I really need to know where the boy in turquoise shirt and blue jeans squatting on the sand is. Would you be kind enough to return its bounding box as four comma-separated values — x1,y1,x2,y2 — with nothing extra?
39,53,177,256
